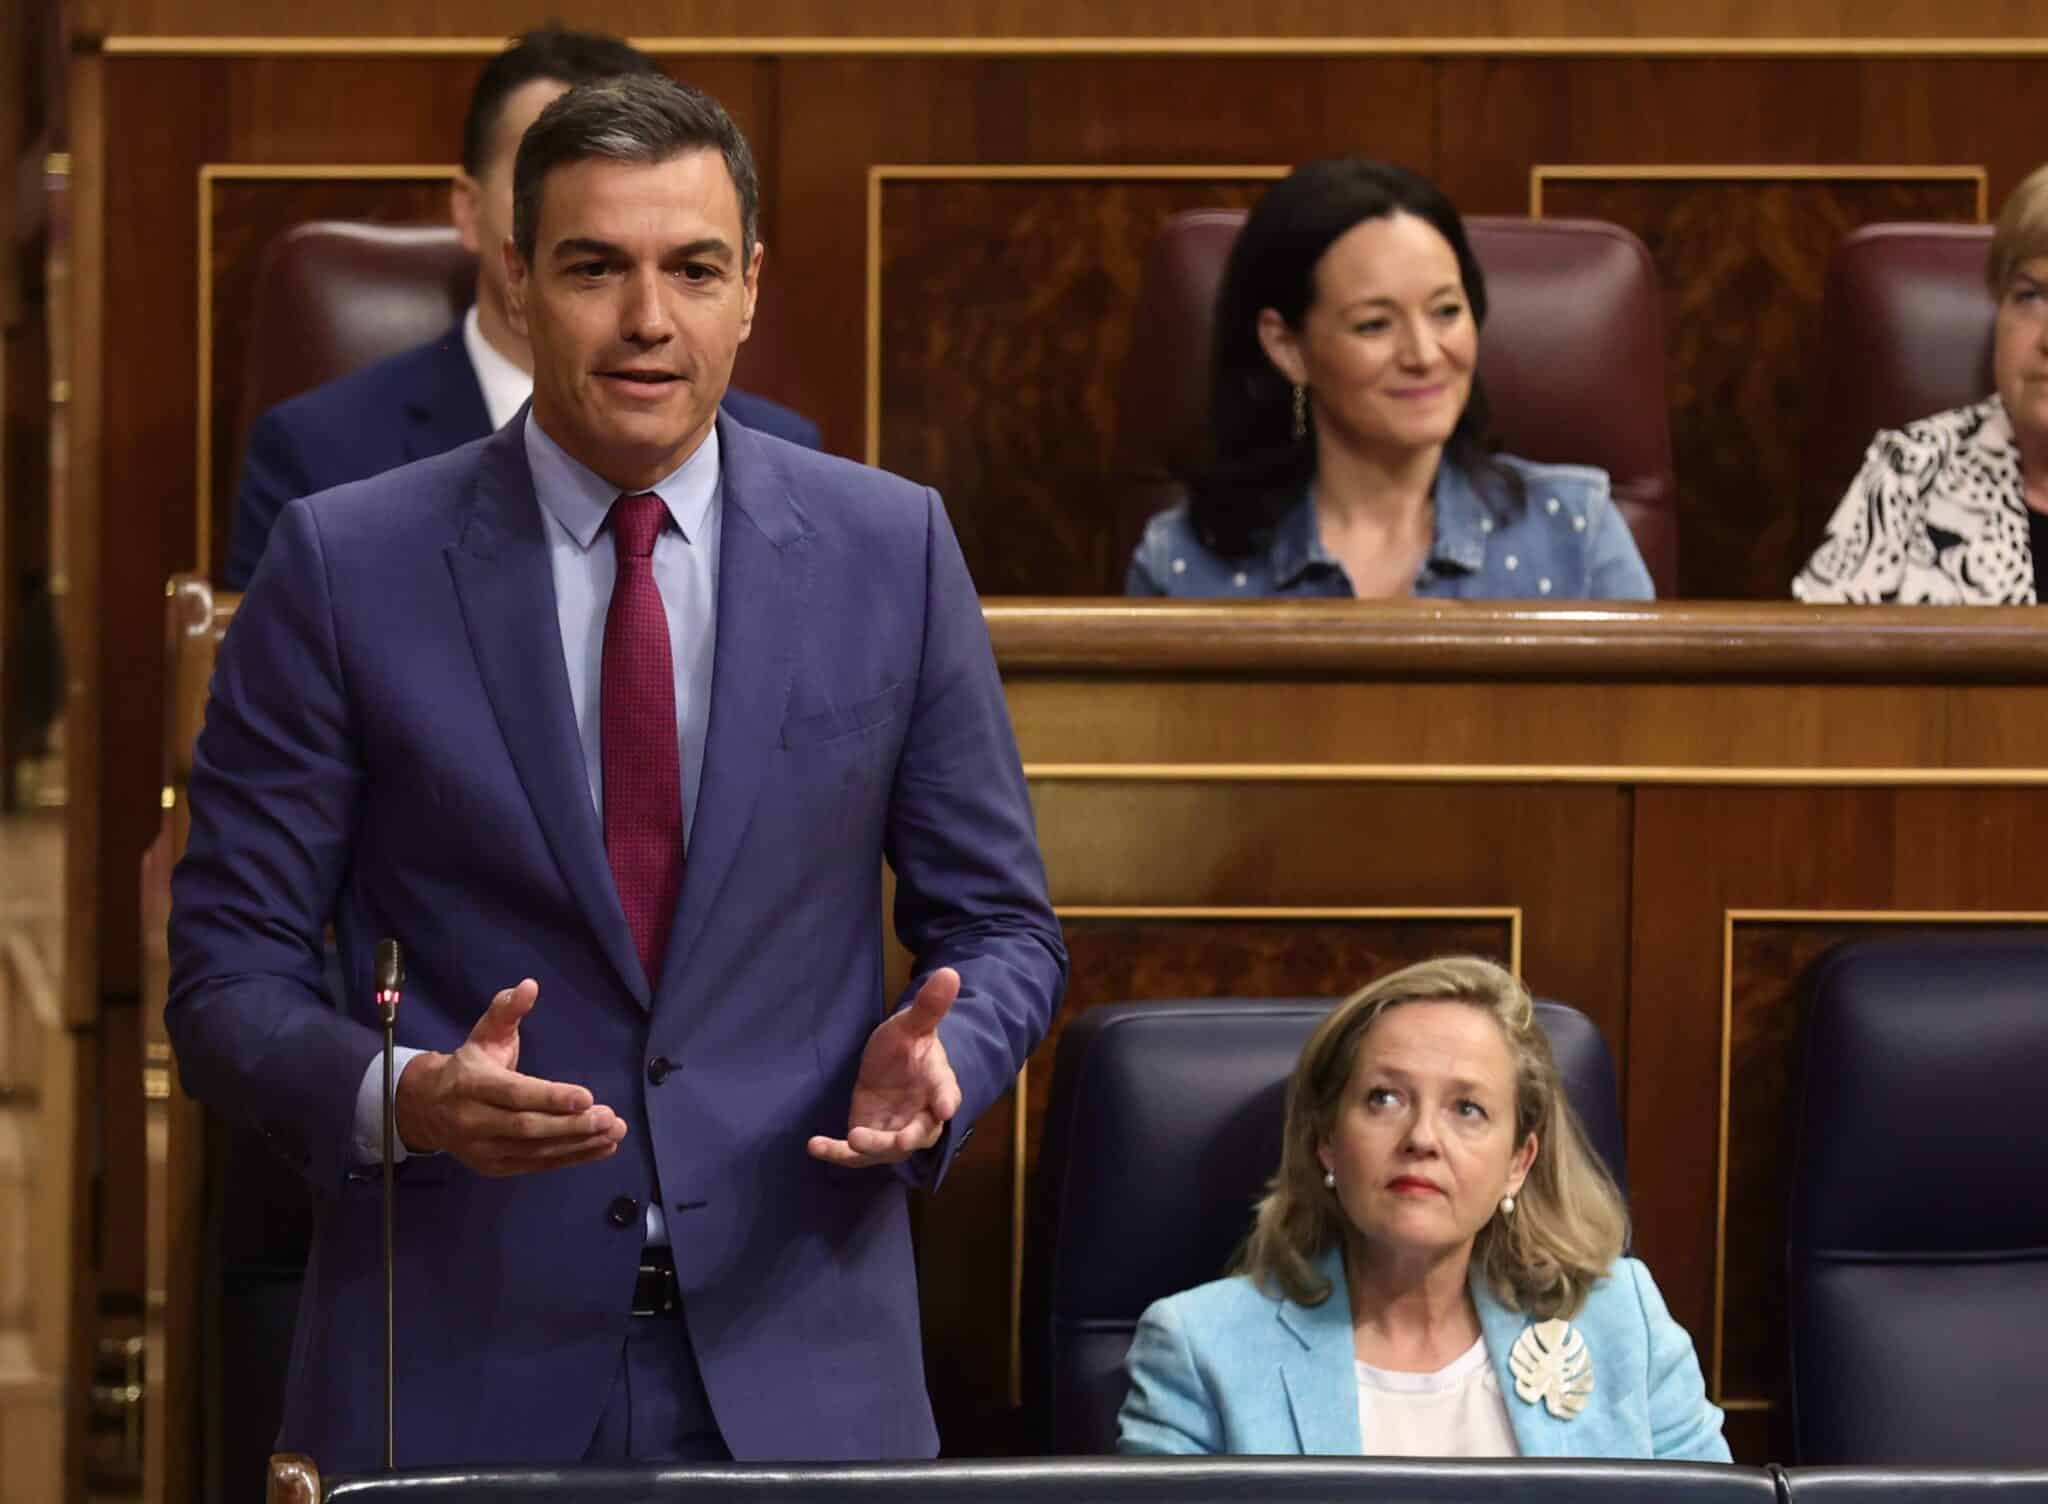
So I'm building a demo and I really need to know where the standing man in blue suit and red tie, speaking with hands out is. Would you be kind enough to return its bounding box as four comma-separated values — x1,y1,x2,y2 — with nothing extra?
166,78,1065,1471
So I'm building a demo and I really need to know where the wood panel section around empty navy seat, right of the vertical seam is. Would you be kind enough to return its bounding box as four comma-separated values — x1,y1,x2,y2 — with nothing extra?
1626,787,2048,1457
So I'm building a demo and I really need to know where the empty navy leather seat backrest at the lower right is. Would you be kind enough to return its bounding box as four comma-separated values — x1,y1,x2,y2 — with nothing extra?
1788,932,2048,1467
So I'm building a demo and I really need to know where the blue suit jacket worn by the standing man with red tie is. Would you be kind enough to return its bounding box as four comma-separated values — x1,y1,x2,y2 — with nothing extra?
166,418,1065,1471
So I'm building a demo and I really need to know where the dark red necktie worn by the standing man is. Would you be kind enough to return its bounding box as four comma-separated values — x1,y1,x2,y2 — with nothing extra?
600,494,682,986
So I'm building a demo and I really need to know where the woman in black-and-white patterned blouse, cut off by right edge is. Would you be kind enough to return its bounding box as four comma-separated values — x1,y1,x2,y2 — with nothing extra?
1792,166,2048,607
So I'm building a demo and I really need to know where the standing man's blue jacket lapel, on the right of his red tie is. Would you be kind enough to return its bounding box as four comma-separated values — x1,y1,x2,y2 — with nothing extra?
659,414,811,988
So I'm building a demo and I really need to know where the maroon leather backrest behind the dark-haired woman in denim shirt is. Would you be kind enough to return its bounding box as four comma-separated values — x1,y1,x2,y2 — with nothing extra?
1112,209,1677,594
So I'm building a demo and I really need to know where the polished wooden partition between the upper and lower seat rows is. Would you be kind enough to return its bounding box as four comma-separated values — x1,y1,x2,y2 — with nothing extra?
150,586,2048,1461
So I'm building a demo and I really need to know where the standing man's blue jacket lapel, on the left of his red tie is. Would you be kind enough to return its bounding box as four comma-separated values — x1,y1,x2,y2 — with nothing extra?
446,422,647,1008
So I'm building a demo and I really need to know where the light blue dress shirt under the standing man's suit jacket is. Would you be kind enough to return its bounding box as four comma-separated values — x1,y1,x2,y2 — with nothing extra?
354,410,723,1244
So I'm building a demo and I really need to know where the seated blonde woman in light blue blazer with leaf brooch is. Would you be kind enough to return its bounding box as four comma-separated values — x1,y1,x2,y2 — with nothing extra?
1118,957,1729,1461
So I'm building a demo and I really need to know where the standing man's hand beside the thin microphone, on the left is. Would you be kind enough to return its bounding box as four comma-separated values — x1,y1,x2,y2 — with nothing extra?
397,977,627,1174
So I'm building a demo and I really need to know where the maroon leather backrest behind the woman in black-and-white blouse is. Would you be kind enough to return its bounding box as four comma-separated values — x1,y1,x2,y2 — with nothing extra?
1800,223,1997,565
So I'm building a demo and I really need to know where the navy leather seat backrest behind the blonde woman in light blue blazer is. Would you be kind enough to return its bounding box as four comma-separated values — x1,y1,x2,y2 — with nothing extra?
1024,998,1626,1455
